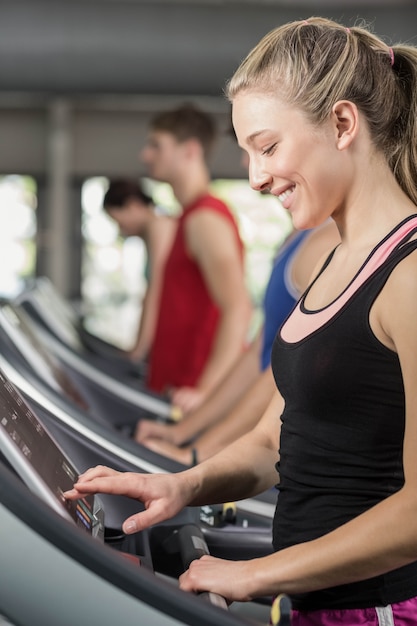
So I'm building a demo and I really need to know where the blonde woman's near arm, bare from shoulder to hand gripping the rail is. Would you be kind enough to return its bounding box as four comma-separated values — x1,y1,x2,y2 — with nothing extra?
181,249,417,600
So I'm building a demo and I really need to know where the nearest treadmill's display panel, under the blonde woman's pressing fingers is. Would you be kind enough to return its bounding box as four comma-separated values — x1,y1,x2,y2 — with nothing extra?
0,370,102,536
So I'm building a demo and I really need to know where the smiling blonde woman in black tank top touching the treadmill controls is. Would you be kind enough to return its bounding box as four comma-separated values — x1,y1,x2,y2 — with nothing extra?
67,17,417,626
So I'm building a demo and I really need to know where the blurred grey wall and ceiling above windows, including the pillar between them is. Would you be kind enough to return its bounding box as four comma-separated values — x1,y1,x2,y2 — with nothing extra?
0,0,417,295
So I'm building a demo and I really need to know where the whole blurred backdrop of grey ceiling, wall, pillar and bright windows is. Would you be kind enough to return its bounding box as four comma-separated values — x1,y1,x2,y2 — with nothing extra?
0,0,417,347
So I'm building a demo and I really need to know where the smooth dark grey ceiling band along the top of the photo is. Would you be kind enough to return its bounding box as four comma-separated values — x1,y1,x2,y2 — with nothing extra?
0,0,417,97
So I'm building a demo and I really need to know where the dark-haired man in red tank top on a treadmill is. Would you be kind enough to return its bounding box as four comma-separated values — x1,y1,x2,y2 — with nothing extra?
142,104,251,412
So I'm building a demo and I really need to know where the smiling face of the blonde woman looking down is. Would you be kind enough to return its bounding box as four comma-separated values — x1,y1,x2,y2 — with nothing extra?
233,91,352,229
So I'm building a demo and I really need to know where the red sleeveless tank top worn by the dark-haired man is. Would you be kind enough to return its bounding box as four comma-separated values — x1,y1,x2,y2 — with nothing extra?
147,194,243,392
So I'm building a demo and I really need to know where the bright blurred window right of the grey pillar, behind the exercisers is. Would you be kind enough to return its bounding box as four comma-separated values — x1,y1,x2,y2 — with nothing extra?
81,177,291,348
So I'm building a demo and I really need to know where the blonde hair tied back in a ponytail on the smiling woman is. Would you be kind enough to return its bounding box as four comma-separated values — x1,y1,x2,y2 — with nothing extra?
226,17,417,203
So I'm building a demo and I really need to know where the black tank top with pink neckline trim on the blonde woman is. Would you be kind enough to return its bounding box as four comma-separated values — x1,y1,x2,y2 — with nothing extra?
272,216,417,610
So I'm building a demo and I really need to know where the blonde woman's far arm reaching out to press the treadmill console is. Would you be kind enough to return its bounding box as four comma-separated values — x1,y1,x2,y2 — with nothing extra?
65,392,283,533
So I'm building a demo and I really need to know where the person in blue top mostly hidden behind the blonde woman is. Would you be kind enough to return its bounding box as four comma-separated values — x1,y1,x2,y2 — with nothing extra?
135,221,339,465
